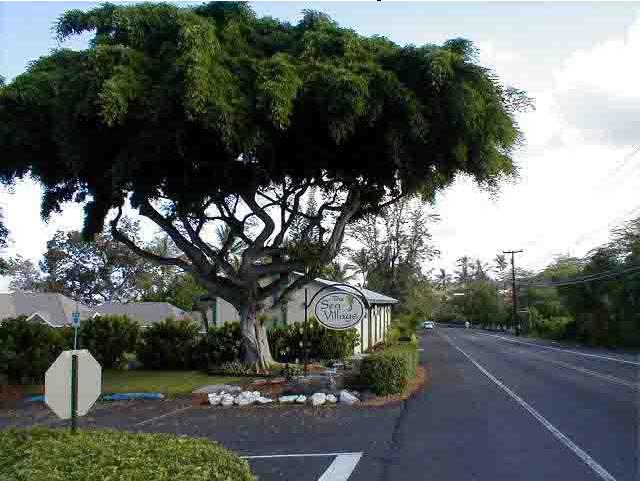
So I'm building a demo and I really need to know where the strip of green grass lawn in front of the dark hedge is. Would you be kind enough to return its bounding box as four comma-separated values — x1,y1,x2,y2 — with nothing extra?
25,369,252,395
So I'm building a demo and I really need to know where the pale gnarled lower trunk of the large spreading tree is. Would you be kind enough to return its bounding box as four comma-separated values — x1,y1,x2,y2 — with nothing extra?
239,302,274,372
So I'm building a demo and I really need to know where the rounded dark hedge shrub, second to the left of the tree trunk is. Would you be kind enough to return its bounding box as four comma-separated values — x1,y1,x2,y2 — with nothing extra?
136,318,198,370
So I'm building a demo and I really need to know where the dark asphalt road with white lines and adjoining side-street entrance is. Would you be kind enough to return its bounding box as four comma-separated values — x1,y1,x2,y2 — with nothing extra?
0,328,639,481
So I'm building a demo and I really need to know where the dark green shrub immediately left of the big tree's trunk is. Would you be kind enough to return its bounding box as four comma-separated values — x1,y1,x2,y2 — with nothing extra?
196,322,242,370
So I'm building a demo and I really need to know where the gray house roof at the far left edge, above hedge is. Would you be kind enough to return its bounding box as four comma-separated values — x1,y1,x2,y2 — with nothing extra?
0,291,95,327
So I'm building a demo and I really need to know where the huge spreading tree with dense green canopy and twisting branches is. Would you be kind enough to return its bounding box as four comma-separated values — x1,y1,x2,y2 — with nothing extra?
0,2,529,368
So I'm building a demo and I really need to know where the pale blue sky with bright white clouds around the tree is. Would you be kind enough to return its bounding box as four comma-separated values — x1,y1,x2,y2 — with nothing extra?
0,1,641,291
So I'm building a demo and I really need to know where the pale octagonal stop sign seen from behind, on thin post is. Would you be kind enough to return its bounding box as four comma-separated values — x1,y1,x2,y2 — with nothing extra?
45,349,102,433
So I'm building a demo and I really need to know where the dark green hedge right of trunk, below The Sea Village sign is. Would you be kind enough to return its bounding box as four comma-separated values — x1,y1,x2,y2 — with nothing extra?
267,317,360,362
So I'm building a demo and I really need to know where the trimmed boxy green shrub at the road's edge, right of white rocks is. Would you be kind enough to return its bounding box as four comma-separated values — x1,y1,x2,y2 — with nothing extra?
360,344,418,396
